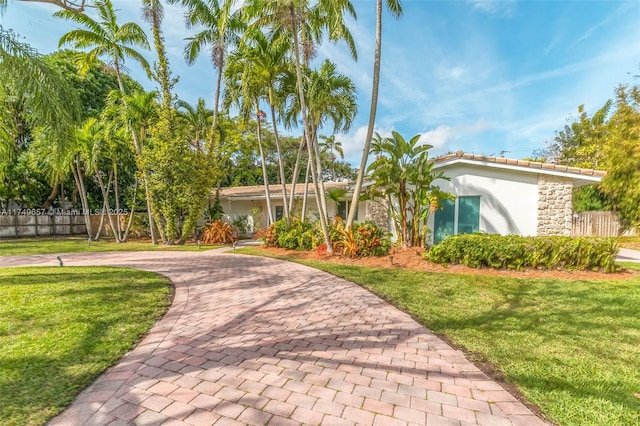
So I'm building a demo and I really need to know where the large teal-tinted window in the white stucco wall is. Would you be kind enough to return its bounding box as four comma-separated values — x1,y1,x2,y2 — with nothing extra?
433,196,480,244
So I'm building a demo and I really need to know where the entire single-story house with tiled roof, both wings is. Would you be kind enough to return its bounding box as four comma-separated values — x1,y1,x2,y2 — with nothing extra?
215,151,606,243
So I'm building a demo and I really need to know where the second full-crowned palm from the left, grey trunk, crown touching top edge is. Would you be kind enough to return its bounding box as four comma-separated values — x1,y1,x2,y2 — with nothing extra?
169,0,245,140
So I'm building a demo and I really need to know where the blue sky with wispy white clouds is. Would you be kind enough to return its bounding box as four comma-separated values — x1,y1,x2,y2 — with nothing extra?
0,0,640,166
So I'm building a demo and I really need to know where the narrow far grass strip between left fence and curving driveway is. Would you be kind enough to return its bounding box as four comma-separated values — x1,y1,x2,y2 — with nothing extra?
0,238,214,256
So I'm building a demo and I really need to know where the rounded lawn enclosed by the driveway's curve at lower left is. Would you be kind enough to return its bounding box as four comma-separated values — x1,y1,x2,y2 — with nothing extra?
0,267,172,425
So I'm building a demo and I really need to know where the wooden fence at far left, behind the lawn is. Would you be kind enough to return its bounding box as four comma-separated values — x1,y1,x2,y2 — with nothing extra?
0,213,87,238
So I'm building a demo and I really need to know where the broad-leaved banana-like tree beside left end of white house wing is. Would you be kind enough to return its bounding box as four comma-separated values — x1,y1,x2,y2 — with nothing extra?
367,132,450,247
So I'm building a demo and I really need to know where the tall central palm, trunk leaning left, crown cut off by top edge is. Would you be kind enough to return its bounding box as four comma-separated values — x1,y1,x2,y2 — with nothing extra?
246,0,356,252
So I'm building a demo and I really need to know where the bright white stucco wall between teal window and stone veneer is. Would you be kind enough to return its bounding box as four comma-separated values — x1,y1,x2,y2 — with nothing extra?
429,164,538,235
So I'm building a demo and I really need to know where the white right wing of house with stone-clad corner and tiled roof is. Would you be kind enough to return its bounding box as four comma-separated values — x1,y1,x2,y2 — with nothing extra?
428,151,606,244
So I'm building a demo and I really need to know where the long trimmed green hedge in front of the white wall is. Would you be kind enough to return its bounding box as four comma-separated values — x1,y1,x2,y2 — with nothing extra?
424,234,618,272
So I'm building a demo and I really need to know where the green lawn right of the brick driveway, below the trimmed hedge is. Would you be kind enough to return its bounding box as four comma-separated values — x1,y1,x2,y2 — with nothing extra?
239,248,640,425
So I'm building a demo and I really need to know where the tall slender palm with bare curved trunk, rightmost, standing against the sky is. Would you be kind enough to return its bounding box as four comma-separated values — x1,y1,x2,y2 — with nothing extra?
345,0,402,229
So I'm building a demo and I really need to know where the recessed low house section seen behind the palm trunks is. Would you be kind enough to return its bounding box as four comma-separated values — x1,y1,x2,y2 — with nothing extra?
219,182,389,230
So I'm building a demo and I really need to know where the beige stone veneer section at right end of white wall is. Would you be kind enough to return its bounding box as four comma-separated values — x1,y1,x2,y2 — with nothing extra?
537,175,573,236
